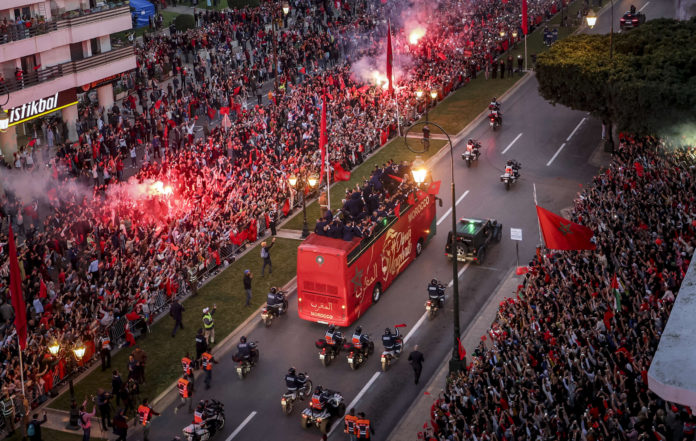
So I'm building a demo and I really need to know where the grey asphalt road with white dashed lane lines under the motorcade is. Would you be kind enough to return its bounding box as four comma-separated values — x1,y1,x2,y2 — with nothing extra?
141,0,673,441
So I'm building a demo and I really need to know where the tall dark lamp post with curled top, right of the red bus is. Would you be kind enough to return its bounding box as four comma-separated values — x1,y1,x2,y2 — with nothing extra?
404,119,466,372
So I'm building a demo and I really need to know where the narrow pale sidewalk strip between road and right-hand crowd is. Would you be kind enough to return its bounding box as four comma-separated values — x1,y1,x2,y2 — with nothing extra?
387,268,522,441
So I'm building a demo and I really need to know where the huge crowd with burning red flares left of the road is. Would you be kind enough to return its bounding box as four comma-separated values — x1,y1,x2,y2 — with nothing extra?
0,0,572,414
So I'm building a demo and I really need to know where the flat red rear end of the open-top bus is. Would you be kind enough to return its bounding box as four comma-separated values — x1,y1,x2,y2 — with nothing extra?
297,246,354,326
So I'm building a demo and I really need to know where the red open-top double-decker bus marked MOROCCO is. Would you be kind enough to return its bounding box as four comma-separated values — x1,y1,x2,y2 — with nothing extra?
297,194,436,326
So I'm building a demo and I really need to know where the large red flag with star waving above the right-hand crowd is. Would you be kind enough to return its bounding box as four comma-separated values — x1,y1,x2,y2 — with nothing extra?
537,205,597,251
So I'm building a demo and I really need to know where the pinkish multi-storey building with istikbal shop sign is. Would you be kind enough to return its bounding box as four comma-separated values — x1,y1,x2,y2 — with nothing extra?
0,0,136,162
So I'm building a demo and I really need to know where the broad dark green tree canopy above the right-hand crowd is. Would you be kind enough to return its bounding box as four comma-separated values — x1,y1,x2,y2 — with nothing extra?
536,19,696,134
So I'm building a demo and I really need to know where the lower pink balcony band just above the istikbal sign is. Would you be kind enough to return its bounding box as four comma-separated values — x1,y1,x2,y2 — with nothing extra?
3,46,136,108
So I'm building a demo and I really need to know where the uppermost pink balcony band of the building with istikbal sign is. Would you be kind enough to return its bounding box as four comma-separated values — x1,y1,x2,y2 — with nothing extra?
0,2,132,60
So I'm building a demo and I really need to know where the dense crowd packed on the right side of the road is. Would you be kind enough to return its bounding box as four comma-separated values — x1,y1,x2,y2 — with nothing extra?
425,137,696,441
